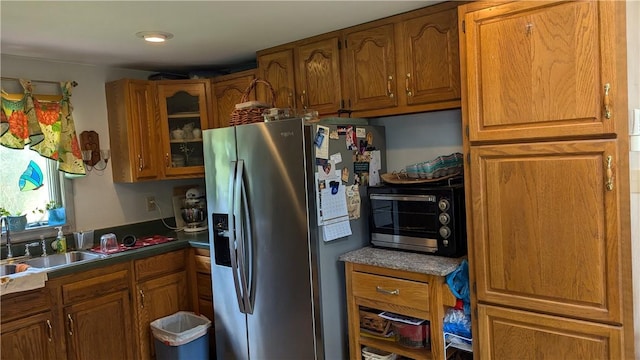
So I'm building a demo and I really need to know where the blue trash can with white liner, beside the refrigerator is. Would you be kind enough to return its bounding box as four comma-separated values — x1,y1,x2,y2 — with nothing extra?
151,311,211,360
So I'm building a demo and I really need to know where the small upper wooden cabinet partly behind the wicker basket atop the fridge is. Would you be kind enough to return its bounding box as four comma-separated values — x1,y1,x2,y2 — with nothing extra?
213,70,256,128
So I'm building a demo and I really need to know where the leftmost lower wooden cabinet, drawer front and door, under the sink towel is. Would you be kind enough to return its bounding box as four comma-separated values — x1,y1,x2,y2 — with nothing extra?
0,288,59,360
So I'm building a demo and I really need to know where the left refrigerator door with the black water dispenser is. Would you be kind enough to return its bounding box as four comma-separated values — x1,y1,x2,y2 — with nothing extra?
203,127,249,359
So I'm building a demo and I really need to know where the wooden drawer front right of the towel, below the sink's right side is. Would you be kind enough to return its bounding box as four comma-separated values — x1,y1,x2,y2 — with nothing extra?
62,270,129,304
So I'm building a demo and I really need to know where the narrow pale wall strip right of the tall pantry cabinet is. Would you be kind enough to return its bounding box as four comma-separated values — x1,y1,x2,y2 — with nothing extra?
627,1,640,359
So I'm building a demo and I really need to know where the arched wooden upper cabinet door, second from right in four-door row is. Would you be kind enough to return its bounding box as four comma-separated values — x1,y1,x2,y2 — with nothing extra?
342,24,398,111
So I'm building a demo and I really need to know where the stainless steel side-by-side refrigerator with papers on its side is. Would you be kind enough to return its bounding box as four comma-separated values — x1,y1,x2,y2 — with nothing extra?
203,118,386,360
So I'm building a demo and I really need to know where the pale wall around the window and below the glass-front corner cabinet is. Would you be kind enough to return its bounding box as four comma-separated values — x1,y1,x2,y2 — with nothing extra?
1,55,204,230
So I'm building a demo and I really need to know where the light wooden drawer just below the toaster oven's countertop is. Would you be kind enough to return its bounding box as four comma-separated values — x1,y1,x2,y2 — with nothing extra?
352,272,429,311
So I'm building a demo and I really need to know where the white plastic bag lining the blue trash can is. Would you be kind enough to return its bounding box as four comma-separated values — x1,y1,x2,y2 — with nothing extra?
150,311,211,346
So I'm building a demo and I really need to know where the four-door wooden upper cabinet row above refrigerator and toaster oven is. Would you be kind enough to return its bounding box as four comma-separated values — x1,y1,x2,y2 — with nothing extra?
257,2,460,117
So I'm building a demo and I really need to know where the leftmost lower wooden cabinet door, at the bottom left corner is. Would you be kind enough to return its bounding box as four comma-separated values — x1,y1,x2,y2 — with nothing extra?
0,311,61,360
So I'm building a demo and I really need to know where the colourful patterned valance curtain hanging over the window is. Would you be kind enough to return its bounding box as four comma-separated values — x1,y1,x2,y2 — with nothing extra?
0,79,85,175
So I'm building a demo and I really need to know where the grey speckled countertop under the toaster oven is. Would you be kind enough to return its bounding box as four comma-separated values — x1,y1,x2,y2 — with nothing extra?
339,247,464,276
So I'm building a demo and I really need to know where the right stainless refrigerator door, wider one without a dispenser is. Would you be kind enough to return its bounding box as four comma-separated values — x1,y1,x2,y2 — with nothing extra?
235,119,317,359
